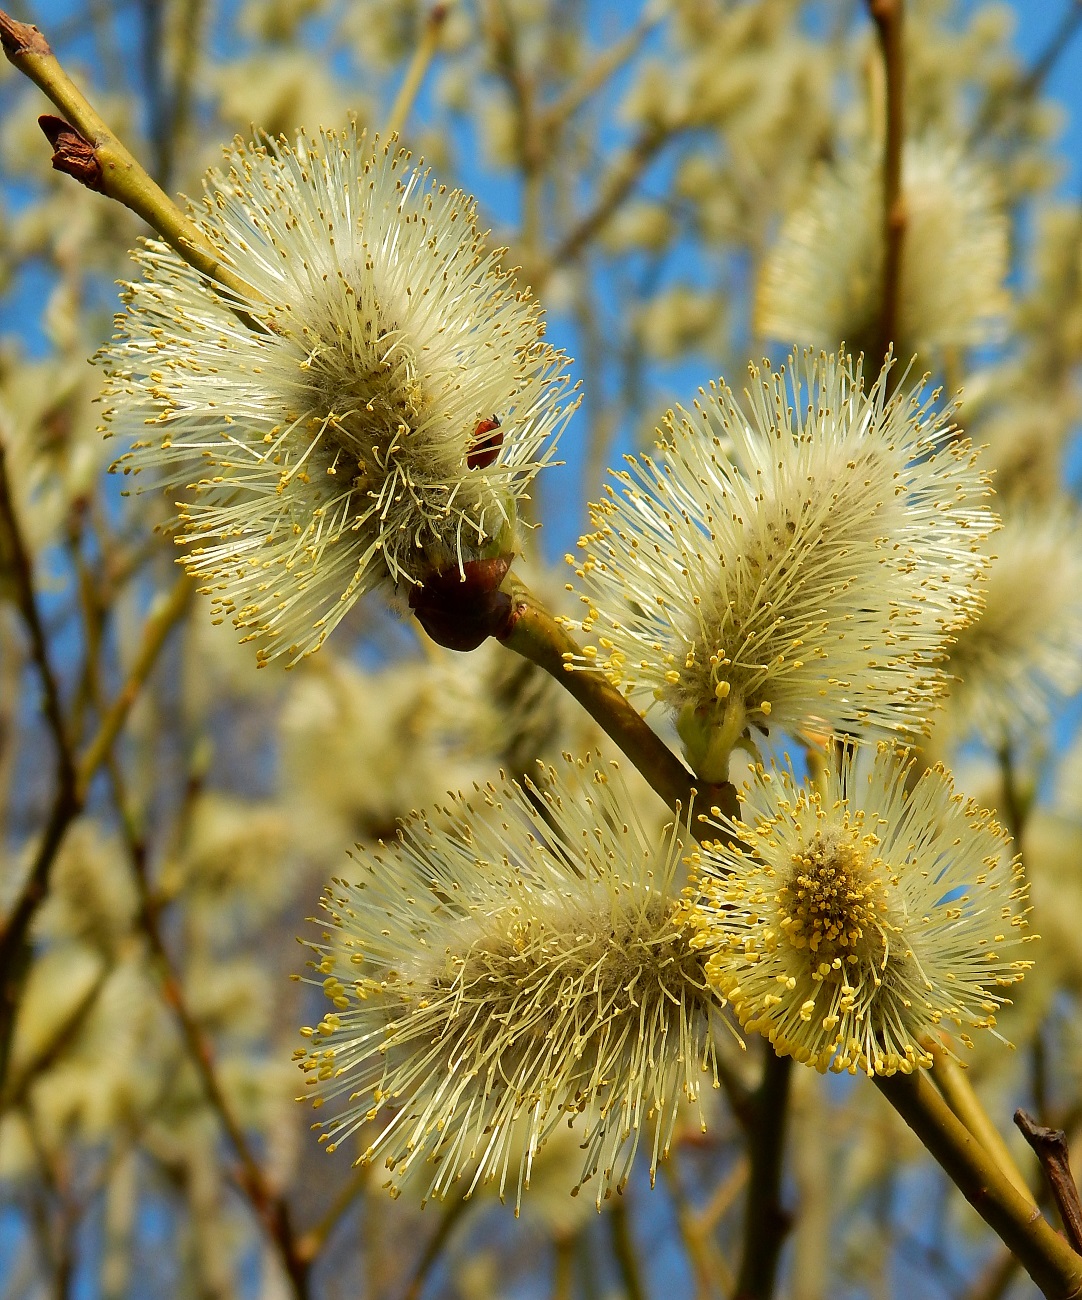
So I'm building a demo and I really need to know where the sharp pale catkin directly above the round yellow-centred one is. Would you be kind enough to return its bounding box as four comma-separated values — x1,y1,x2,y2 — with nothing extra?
568,354,994,780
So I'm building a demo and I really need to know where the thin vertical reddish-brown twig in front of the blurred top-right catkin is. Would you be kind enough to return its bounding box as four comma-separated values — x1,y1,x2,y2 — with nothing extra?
867,0,906,373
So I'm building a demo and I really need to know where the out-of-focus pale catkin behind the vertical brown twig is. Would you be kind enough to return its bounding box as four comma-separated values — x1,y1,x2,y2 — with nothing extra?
754,140,1009,364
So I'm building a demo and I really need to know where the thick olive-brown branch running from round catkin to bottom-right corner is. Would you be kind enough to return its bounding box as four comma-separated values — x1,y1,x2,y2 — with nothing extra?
875,1070,1082,1300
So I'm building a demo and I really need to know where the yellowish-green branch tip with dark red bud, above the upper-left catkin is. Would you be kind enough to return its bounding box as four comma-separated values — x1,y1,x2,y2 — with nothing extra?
0,9,263,309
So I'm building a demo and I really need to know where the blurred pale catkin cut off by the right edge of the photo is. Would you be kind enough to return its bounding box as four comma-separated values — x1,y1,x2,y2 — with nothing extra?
943,507,1082,748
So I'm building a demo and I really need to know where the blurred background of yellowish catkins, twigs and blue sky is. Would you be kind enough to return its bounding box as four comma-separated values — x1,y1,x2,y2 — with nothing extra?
0,0,1082,1300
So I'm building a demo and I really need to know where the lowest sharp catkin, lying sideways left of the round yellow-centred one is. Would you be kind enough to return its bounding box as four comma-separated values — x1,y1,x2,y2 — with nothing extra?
297,759,717,1204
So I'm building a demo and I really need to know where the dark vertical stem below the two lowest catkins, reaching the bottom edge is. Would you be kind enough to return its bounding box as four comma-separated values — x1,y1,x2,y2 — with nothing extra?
735,1045,793,1300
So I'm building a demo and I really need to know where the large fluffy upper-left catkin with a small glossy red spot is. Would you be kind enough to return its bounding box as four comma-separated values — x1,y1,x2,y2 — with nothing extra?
104,129,570,662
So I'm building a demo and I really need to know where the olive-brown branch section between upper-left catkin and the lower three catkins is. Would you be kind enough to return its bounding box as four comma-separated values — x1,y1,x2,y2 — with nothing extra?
501,575,736,816
